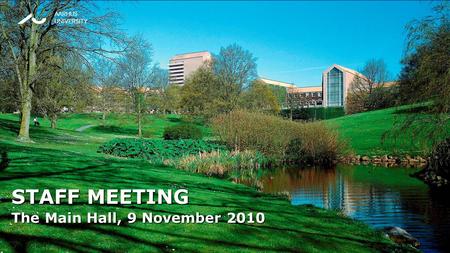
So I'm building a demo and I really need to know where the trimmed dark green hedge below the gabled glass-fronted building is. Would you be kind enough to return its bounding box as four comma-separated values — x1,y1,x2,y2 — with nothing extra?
281,107,345,120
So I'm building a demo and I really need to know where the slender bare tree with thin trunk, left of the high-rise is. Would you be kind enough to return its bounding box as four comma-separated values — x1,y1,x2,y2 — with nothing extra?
118,36,152,137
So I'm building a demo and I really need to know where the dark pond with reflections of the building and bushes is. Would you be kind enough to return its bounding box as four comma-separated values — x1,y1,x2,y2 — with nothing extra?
243,165,450,252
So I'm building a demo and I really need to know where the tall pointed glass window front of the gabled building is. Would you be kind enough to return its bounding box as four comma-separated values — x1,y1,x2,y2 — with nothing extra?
327,68,344,106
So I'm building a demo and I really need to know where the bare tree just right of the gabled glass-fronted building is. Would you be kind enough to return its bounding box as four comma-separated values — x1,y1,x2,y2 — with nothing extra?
346,59,389,114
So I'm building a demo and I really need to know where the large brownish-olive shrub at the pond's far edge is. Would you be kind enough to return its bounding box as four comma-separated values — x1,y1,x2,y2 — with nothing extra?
212,111,344,164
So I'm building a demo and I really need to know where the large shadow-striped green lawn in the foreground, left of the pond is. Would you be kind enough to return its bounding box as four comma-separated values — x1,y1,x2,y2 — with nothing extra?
0,114,402,252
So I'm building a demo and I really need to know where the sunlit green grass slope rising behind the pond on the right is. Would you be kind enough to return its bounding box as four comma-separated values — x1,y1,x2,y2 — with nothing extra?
326,107,450,155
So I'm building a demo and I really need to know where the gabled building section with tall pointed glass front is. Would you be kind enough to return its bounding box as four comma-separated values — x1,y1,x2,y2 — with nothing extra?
322,64,363,107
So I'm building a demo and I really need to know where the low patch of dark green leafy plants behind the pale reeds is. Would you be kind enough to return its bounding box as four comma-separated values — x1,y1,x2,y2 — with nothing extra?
98,138,225,163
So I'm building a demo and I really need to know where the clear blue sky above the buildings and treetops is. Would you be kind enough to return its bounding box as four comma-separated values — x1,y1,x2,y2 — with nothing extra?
100,1,432,86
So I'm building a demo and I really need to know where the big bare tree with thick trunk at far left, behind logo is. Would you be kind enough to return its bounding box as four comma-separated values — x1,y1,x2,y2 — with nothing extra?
0,0,123,141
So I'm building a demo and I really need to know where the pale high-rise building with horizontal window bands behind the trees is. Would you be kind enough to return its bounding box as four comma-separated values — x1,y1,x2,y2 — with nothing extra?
169,51,212,86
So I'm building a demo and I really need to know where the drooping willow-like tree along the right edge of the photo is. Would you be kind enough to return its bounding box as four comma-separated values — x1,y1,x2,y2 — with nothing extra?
394,1,450,143
